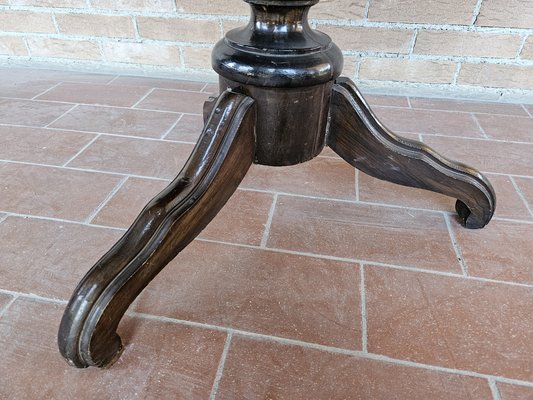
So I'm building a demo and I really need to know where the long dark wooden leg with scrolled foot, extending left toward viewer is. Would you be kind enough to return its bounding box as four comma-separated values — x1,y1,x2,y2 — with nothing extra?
58,91,255,367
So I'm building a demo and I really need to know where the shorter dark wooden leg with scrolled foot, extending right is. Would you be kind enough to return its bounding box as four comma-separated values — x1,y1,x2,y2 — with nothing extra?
327,78,496,228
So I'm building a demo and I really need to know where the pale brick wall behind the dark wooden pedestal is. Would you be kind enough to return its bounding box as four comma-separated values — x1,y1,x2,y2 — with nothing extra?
0,0,533,93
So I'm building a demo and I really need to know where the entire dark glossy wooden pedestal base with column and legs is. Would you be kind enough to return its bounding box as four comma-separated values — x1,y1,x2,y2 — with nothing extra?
58,0,496,367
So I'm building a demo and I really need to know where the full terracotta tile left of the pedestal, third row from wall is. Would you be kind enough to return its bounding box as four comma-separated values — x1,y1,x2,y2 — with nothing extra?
51,106,179,138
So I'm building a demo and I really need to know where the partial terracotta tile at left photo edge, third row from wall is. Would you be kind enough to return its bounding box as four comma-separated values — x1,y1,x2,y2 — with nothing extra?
0,98,72,127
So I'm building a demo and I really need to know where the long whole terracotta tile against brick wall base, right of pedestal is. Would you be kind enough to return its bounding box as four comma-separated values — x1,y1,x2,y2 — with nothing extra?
411,97,528,117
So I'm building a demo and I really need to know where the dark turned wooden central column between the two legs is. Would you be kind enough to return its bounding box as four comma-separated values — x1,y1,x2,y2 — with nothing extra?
212,0,343,166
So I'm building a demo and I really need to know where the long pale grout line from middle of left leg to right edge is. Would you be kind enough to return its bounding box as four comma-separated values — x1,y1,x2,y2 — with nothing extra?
195,238,533,288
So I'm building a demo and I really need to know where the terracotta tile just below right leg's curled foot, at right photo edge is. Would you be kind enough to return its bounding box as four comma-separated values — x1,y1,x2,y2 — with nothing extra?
454,220,533,285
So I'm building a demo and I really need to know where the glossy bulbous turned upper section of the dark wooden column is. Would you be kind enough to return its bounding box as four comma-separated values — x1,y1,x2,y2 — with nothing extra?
212,0,343,88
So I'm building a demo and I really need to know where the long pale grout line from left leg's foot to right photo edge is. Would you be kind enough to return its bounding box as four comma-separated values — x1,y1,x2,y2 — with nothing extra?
126,312,533,387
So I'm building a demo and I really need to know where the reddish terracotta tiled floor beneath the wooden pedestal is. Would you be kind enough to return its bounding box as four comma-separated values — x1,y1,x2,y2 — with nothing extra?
0,69,533,400
